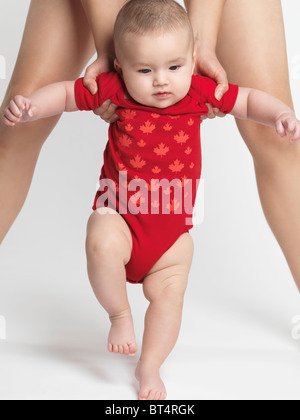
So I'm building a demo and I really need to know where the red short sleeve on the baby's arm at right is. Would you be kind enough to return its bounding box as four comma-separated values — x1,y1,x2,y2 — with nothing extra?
192,76,239,114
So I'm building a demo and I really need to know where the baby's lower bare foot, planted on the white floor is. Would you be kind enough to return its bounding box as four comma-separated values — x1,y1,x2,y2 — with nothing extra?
135,362,167,400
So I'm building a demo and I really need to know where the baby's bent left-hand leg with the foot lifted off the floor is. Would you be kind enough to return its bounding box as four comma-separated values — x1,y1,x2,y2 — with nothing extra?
86,211,137,356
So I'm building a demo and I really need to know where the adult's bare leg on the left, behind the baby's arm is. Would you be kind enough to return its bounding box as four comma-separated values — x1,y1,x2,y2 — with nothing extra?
0,0,95,244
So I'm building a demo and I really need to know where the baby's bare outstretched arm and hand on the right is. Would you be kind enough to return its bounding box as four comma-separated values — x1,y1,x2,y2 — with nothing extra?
231,87,300,142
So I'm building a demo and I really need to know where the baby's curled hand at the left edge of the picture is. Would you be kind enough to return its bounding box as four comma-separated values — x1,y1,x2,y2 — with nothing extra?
2,95,36,127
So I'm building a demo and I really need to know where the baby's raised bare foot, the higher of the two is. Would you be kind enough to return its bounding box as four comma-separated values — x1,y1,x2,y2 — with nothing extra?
108,310,137,357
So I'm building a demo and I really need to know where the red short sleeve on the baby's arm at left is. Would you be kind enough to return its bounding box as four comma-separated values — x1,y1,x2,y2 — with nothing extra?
75,72,120,111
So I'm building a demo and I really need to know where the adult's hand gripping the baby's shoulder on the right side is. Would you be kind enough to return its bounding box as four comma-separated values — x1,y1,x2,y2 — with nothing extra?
195,49,229,120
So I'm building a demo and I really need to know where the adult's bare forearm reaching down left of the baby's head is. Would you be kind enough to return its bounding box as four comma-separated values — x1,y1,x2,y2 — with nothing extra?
81,0,126,55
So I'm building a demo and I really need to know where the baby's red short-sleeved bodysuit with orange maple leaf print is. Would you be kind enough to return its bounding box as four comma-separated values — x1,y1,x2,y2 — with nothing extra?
75,72,238,283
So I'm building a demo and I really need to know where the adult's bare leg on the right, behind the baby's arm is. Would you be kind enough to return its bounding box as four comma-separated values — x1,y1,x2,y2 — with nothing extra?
217,0,300,290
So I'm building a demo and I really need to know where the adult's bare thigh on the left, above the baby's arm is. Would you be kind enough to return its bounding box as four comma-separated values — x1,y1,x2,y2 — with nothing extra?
2,0,95,106
